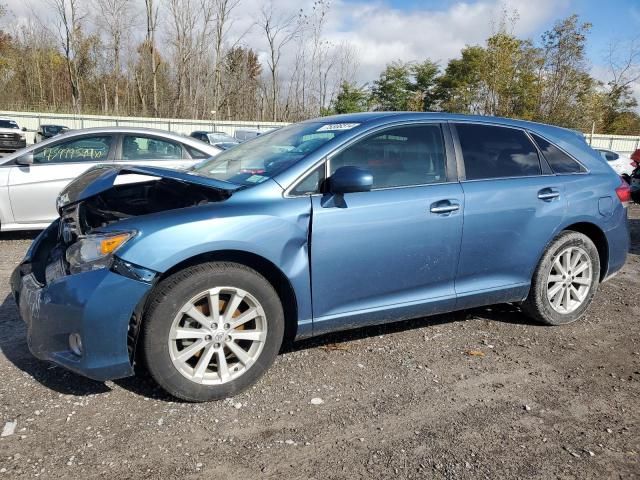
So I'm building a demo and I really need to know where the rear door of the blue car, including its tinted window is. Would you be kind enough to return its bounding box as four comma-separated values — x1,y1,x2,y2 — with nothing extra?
453,123,566,308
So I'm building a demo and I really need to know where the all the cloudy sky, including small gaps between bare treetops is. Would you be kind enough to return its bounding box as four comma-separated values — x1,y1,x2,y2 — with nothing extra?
4,0,571,82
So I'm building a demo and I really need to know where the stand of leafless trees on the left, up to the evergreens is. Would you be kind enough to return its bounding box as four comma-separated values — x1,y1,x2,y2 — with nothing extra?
0,0,355,121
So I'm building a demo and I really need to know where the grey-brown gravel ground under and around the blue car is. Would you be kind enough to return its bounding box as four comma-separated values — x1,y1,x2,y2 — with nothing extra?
0,206,640,479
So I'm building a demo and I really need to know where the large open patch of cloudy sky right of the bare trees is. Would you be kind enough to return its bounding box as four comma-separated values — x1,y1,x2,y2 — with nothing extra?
318,0,569,78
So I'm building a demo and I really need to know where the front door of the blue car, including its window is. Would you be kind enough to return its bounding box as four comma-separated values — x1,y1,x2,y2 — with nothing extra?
311,124,464,334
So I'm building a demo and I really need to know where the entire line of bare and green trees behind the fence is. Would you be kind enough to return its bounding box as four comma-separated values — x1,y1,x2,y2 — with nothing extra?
0,0,640,134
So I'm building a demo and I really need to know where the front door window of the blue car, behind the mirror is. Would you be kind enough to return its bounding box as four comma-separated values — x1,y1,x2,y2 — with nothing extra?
331,125,447,188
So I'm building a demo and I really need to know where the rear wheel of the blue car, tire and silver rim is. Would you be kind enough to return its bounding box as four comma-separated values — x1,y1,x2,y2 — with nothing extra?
522,231,600,325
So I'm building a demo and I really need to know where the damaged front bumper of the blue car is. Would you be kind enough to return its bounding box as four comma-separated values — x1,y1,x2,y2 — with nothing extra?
11,234,151,381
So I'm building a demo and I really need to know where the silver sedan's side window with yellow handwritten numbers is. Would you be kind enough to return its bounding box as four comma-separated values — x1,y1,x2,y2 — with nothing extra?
33,135,113,164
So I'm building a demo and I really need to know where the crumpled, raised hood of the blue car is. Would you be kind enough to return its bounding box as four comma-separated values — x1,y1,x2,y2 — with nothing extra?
56,165,241,211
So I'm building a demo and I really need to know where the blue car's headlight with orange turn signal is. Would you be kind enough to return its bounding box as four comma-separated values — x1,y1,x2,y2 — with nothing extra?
66,232,135,273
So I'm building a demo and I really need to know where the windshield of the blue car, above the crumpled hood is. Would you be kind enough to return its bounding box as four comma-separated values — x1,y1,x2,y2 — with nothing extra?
193,122,359,186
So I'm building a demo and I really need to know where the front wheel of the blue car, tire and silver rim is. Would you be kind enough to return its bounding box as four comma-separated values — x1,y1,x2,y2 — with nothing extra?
142,262,284,402
